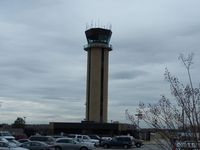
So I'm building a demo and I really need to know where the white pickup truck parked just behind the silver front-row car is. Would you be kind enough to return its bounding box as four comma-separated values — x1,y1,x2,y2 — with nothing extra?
67,134,99,146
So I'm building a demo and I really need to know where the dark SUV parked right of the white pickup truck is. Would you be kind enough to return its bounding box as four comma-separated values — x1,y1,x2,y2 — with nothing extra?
101,136,132,149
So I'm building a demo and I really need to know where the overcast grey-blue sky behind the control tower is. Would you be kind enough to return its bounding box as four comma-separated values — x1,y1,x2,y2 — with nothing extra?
0,0,200,123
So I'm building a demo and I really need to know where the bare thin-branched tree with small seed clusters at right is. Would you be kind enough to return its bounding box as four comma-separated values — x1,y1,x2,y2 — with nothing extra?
126,53,200,150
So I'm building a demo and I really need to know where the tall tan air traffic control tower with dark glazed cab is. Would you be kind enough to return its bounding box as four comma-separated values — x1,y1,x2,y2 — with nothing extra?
84,28,112,123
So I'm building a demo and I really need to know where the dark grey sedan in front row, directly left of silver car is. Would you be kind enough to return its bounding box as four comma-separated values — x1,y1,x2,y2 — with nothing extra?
20,141,54,150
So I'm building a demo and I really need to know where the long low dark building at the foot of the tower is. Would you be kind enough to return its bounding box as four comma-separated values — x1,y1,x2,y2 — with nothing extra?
49,122,135,136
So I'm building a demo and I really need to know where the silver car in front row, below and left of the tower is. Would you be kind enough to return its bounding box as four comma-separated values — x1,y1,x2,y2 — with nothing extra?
55,138,95,150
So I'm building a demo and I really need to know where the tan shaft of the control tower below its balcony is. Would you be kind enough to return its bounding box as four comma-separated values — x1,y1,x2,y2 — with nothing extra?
86,47,109,123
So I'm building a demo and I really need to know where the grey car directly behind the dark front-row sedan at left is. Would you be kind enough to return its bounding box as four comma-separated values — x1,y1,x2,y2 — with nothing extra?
29,135,55,145
